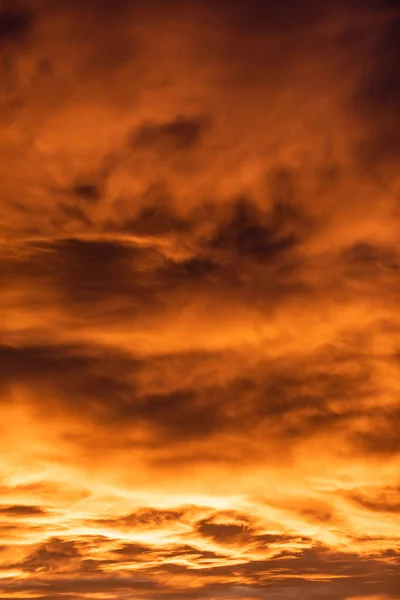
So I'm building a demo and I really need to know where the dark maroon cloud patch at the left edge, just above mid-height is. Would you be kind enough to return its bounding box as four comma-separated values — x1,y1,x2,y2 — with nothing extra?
3,239,163,312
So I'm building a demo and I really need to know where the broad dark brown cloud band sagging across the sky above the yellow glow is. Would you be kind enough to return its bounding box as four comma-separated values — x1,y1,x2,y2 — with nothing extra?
0,332,388,464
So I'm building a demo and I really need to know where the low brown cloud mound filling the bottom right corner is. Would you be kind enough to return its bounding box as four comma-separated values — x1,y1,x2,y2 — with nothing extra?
134,547,398,600
